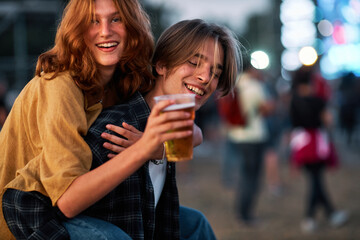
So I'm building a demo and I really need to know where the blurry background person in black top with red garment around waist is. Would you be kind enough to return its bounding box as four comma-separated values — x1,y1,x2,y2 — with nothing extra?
290,66,348,232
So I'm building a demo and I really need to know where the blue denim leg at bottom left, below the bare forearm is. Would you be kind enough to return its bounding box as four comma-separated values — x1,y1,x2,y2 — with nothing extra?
62,215,131,240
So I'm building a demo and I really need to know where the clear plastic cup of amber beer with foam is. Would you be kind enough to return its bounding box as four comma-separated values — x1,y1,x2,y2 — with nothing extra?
154,94,195,162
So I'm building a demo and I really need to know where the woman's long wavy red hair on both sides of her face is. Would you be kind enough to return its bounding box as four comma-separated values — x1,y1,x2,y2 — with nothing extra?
35,0,154,101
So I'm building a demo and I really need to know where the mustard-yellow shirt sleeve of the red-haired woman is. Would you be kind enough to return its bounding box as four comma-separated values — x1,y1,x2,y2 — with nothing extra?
18,75,92,205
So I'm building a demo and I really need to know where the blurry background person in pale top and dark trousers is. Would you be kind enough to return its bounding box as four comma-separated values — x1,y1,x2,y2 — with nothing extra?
225,57,271,226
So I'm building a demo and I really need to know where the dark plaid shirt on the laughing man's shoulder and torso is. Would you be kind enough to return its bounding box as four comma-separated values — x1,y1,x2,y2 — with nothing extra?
84,92,179,240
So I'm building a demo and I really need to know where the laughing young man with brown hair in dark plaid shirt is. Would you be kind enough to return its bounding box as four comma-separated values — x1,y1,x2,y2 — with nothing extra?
4,19,240,240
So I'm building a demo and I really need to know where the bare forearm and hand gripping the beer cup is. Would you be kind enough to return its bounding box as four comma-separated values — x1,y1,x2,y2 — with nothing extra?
57,101,194,218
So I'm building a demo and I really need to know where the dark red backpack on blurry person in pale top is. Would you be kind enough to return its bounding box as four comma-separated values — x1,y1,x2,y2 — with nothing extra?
217,90,247,126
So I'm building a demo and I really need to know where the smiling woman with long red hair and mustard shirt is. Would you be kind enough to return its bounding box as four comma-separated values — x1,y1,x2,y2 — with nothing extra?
0,0,154,240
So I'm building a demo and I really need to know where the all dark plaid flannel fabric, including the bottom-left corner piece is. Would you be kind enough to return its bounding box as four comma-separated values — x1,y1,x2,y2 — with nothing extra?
3,92,180,240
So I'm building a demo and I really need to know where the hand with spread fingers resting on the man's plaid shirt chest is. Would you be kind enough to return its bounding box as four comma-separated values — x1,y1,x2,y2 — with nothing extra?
101,122,143,158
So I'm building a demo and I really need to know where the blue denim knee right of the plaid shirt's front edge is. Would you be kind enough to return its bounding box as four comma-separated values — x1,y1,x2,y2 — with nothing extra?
179,206,216,240
